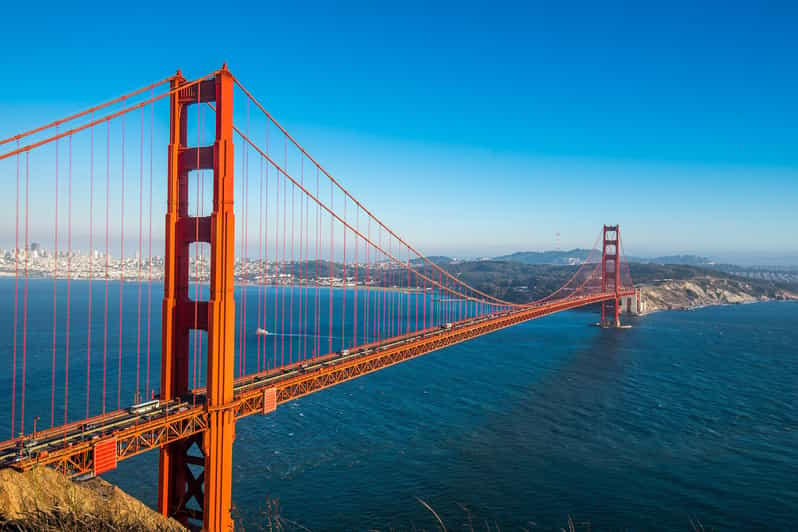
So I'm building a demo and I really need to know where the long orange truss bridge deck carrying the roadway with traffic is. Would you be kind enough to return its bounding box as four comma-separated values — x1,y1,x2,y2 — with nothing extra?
0,290,634,476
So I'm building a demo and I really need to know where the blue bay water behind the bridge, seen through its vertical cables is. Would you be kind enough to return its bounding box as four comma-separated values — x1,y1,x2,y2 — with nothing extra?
0,278,476,426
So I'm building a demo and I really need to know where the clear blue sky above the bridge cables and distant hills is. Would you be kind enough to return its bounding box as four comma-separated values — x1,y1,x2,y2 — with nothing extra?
0,1,798,264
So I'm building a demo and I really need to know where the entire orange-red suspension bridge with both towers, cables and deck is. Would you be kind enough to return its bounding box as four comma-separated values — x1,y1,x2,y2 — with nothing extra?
0,66,636,530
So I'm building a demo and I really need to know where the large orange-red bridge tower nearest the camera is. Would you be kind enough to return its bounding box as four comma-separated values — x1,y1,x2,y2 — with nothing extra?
158,66,235,531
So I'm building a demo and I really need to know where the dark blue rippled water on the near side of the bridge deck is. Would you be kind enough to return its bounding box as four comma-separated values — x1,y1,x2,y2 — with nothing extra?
0,281,798,530
